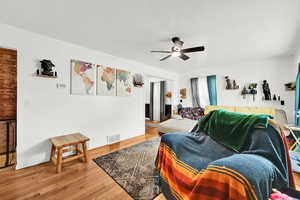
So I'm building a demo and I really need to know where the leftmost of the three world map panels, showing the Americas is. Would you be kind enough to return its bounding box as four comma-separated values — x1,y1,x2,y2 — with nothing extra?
71,60,96,95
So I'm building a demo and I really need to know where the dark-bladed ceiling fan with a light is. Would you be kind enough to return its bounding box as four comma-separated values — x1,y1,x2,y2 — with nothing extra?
150,37,205,61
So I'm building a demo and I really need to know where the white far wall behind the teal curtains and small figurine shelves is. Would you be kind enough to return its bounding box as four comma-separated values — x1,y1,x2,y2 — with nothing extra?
178,58,296,122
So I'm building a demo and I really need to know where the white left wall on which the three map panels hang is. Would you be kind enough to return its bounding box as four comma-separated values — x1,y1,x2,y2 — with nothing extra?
0,24,176,169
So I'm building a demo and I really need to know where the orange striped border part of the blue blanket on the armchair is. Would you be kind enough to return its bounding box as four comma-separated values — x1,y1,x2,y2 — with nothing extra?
156,143,257,200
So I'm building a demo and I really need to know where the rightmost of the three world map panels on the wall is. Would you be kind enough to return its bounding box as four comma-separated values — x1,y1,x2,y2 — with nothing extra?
117,69,133,96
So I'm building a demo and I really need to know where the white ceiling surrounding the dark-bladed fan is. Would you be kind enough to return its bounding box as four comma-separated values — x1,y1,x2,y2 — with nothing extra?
0,0,300,73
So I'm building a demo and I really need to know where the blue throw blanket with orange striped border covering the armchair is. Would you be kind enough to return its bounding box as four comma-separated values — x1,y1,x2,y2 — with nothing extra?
156,125,289,200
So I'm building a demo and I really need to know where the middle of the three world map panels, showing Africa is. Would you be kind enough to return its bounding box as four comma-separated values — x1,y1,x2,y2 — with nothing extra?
97,65,117,96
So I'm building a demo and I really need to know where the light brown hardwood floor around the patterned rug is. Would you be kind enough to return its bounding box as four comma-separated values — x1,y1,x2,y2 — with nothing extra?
0,127,300,200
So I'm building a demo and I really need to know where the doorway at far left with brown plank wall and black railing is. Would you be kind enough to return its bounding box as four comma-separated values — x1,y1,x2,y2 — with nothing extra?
0,48,17,169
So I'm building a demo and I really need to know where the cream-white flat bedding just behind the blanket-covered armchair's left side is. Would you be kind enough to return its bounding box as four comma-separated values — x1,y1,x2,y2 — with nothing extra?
158,118,198,133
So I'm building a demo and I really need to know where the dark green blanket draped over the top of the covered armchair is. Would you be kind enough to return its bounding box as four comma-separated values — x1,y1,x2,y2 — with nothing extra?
198,110,272,152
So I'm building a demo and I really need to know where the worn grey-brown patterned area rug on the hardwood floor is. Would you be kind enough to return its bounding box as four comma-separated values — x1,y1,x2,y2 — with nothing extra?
94,138,160,200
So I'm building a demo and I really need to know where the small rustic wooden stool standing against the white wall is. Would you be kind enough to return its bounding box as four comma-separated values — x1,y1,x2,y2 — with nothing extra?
50,133,90,173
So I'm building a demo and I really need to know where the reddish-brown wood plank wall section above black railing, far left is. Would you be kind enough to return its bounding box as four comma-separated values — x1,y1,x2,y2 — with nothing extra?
0,48,17,120
